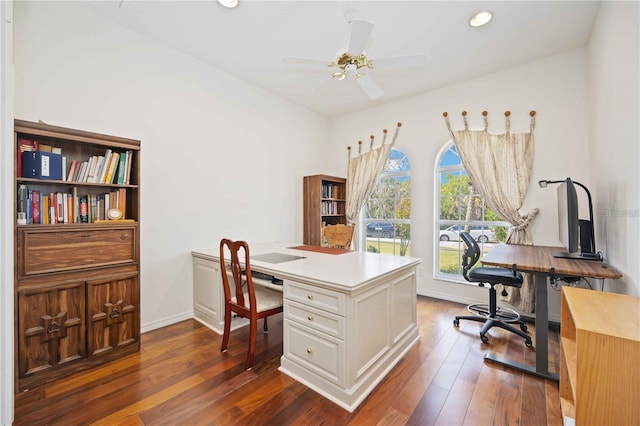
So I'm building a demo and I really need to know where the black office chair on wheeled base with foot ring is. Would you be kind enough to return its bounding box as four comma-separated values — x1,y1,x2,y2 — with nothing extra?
453,232,533,347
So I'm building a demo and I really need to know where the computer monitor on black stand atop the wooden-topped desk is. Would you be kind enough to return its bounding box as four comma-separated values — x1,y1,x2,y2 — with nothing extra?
553,178,602,260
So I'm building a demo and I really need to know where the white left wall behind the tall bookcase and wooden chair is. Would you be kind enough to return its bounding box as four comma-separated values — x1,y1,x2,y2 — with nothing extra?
15,2,328,331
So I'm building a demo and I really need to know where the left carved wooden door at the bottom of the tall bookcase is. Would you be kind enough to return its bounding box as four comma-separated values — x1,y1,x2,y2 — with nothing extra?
18,282,86,378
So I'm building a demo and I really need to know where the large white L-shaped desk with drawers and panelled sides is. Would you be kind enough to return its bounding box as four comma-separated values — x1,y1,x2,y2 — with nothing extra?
192,243,421,411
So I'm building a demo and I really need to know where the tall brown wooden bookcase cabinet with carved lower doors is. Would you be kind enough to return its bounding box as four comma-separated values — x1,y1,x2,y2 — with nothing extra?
14,120,140,391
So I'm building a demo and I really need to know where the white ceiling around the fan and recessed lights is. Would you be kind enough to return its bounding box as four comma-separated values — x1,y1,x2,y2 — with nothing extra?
82,0,600,117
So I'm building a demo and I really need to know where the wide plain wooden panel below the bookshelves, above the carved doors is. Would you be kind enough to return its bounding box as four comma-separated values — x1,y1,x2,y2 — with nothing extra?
18,226,137,276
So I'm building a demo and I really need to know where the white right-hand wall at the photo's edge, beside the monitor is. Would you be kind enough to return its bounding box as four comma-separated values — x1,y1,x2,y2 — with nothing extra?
588,2,640,296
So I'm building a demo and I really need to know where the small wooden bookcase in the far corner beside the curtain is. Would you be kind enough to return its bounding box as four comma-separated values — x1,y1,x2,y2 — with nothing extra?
303,175,347,246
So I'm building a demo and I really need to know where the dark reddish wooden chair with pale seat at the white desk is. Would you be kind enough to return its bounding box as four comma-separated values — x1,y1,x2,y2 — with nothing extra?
220,238,282,370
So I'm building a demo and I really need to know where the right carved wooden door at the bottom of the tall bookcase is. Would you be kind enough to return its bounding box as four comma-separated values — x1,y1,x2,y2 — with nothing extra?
87,273,140,357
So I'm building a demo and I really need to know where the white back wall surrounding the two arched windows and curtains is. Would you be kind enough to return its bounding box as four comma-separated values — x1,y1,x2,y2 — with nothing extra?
329,49,592,321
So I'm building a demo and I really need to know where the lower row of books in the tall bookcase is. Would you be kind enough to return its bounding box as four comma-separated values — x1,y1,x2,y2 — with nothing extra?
18,185,127,225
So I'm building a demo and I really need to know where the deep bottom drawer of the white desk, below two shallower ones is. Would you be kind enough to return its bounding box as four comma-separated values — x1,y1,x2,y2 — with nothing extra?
284,317,345,386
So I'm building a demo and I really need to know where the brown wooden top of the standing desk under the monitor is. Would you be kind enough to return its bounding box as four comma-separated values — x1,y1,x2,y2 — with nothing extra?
481,244,622,279
